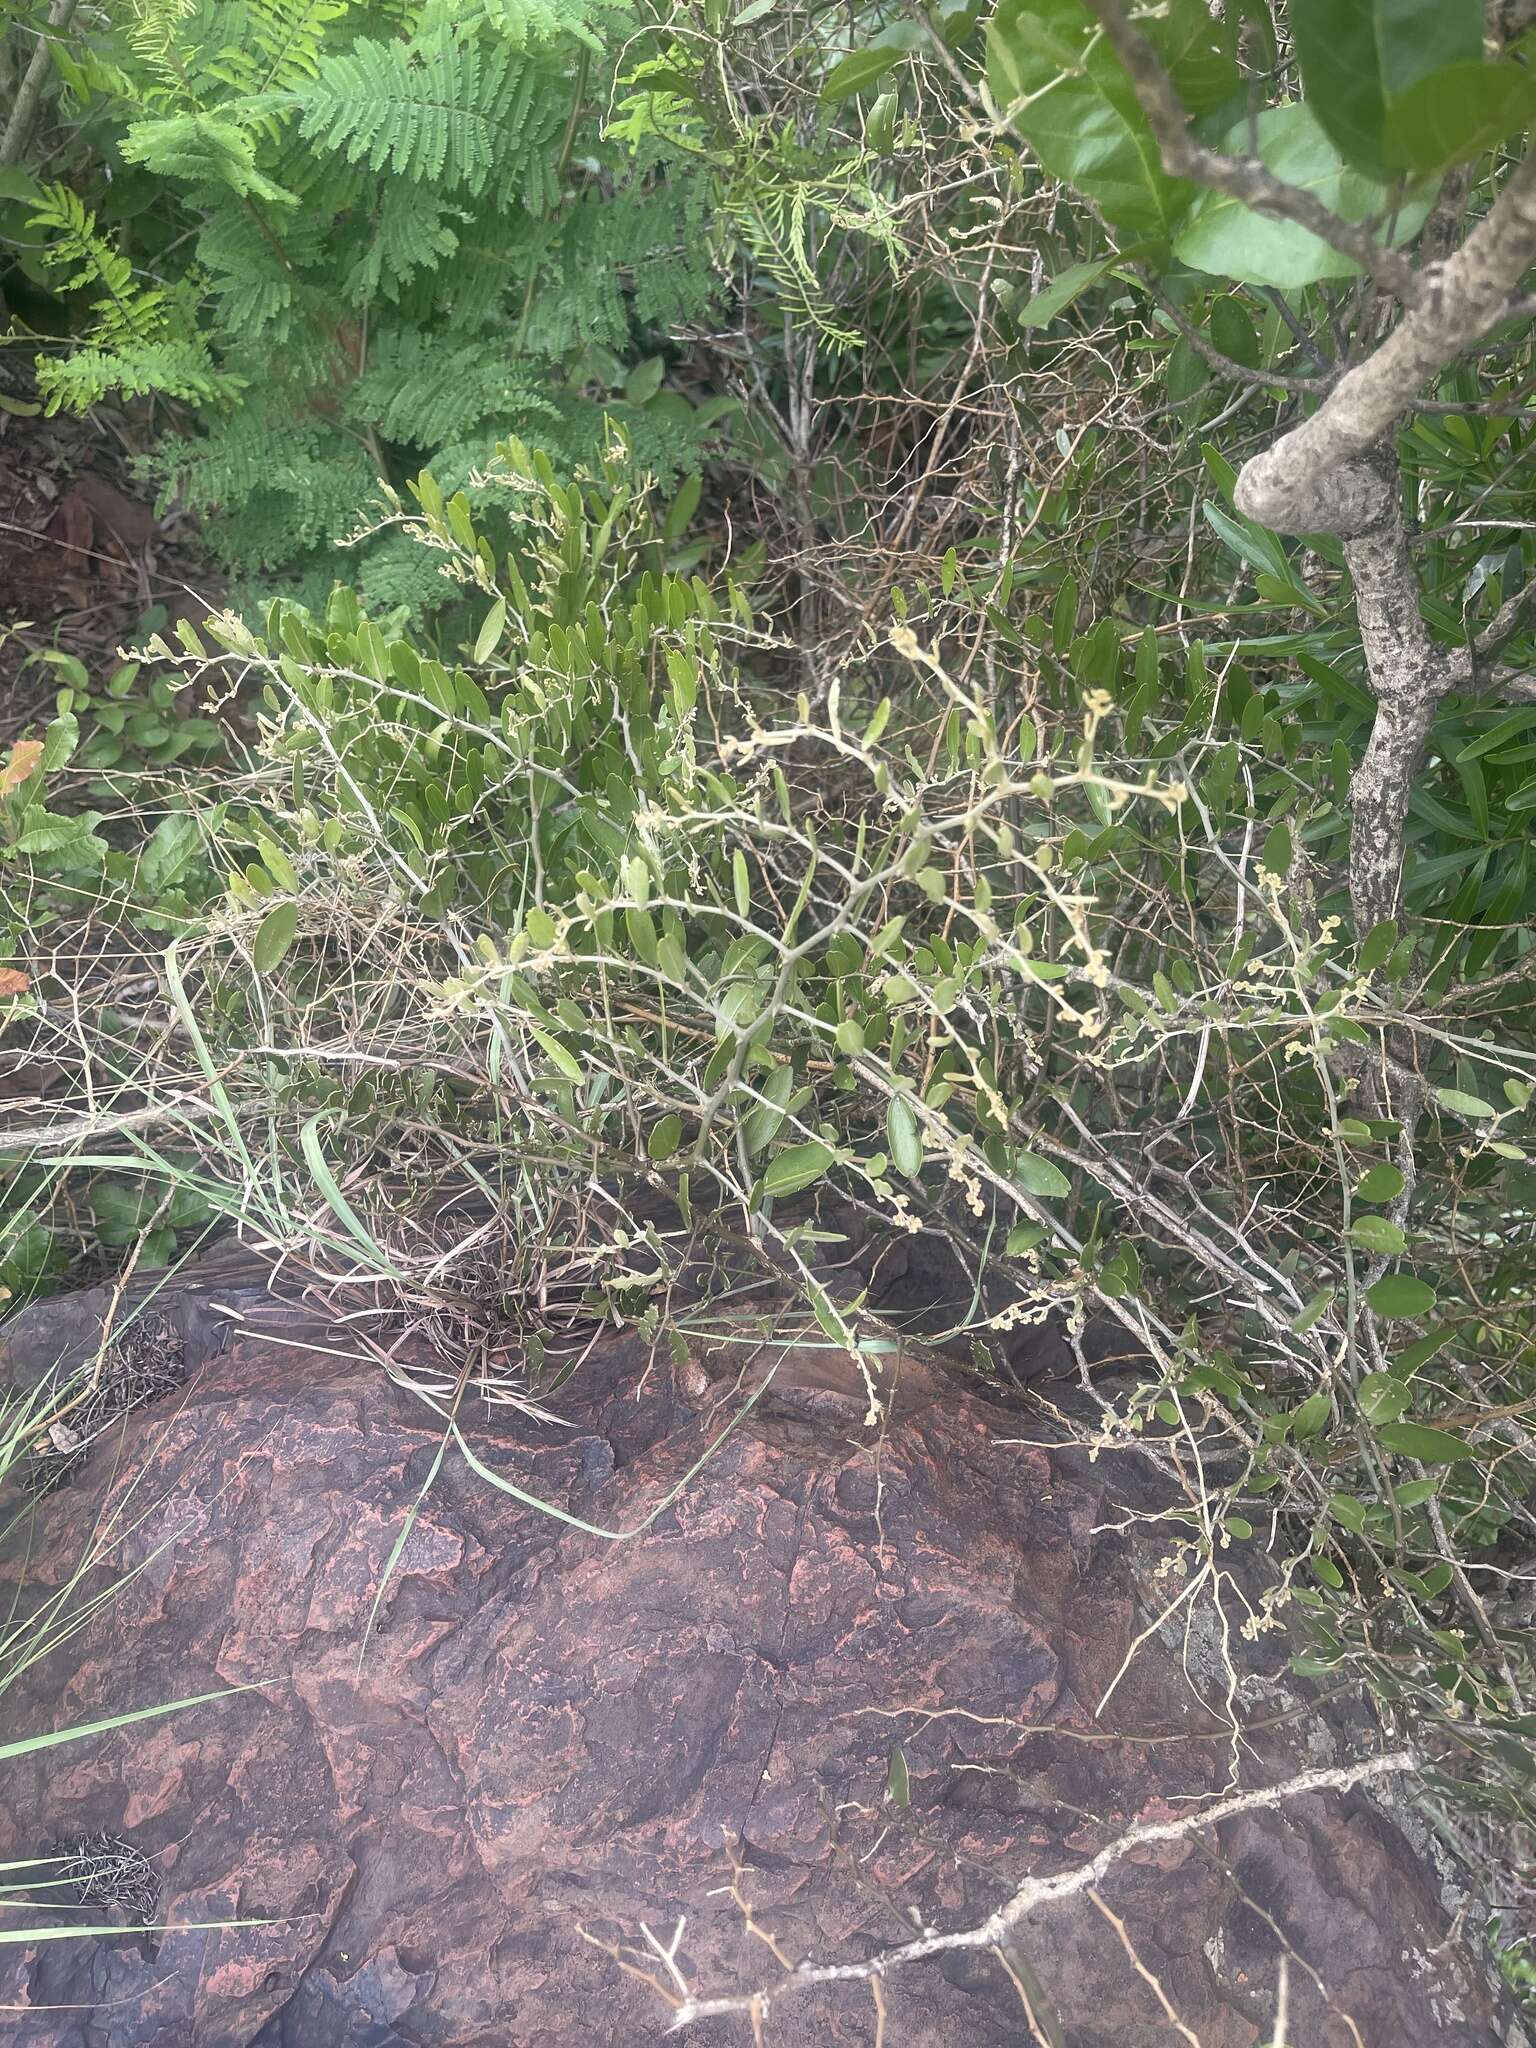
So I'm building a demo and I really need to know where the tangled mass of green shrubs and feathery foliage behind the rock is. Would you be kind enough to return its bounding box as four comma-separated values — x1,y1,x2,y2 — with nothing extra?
0,0,1536,1998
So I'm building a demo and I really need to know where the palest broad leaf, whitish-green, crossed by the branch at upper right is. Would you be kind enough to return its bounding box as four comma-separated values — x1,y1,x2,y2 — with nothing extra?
1174,100,1434,291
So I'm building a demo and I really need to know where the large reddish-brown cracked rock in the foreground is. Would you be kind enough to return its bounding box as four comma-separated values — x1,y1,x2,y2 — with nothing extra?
0,1310,1518,2048
